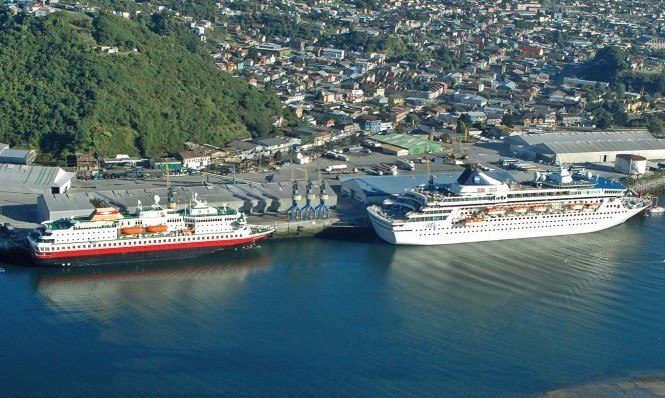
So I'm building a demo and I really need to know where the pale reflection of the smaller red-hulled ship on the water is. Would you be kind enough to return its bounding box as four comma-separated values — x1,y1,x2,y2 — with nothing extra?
35,247,270,320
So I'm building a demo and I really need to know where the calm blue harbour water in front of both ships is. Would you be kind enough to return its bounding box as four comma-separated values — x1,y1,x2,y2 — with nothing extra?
0,210,665,397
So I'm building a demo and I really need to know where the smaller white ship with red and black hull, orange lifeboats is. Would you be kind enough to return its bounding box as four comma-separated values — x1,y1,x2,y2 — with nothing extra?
28,194,275,266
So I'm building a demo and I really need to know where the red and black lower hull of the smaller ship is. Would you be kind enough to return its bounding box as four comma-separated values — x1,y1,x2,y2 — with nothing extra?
33,231,273,267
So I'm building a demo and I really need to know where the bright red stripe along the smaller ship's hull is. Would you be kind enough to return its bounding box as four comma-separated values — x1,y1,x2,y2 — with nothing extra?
35,232,272,260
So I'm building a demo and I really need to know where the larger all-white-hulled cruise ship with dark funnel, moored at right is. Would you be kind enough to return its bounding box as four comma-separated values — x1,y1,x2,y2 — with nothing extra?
367,167,651,245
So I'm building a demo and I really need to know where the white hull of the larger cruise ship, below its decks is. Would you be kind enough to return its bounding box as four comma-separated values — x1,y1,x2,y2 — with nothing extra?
369,206,645,245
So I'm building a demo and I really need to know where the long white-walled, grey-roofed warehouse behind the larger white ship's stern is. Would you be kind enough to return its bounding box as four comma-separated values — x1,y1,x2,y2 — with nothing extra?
506,130,665,163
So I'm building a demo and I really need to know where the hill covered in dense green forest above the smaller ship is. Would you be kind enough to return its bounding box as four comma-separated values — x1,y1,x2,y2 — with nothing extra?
0,10,282,161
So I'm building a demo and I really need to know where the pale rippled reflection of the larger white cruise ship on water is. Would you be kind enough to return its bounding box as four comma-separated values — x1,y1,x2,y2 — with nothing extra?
388,220,644,315
